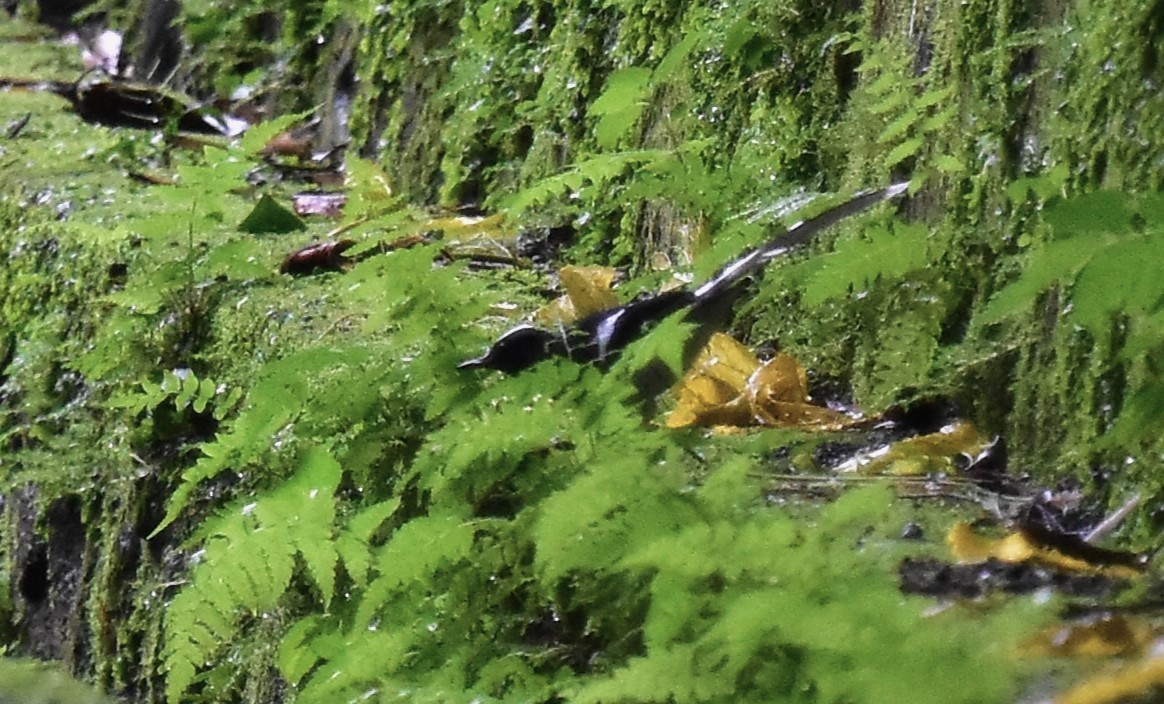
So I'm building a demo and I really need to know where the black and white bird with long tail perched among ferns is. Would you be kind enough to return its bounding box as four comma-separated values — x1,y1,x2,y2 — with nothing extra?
459,183,909,374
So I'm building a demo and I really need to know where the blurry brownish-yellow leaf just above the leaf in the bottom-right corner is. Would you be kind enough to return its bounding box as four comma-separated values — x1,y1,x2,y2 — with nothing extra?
1020,614,1155,657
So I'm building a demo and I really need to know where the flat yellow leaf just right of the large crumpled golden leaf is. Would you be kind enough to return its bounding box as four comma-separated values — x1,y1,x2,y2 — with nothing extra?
837,420,989,476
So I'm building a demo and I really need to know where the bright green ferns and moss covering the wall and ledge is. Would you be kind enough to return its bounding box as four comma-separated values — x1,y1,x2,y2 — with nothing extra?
0,0,1164,702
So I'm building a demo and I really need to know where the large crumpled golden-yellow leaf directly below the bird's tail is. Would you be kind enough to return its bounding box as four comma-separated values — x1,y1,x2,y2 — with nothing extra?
667,333,852,429
